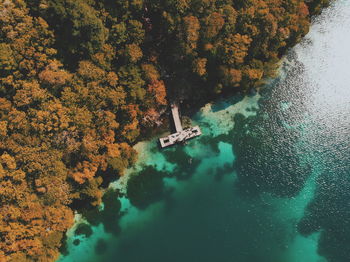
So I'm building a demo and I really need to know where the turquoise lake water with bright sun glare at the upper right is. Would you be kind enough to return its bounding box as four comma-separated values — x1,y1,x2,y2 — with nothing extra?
59,0,350,262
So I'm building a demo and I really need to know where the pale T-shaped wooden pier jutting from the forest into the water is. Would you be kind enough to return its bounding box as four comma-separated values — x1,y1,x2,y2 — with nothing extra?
159,103,202,148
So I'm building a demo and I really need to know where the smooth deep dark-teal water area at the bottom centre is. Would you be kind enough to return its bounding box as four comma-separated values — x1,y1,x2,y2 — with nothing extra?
105,172,304,262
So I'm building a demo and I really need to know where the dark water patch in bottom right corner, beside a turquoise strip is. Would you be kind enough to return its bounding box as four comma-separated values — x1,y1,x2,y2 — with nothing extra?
298,167,350,262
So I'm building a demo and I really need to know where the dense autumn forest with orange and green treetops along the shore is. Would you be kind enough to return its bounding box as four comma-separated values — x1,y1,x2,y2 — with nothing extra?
0,0,328,262
